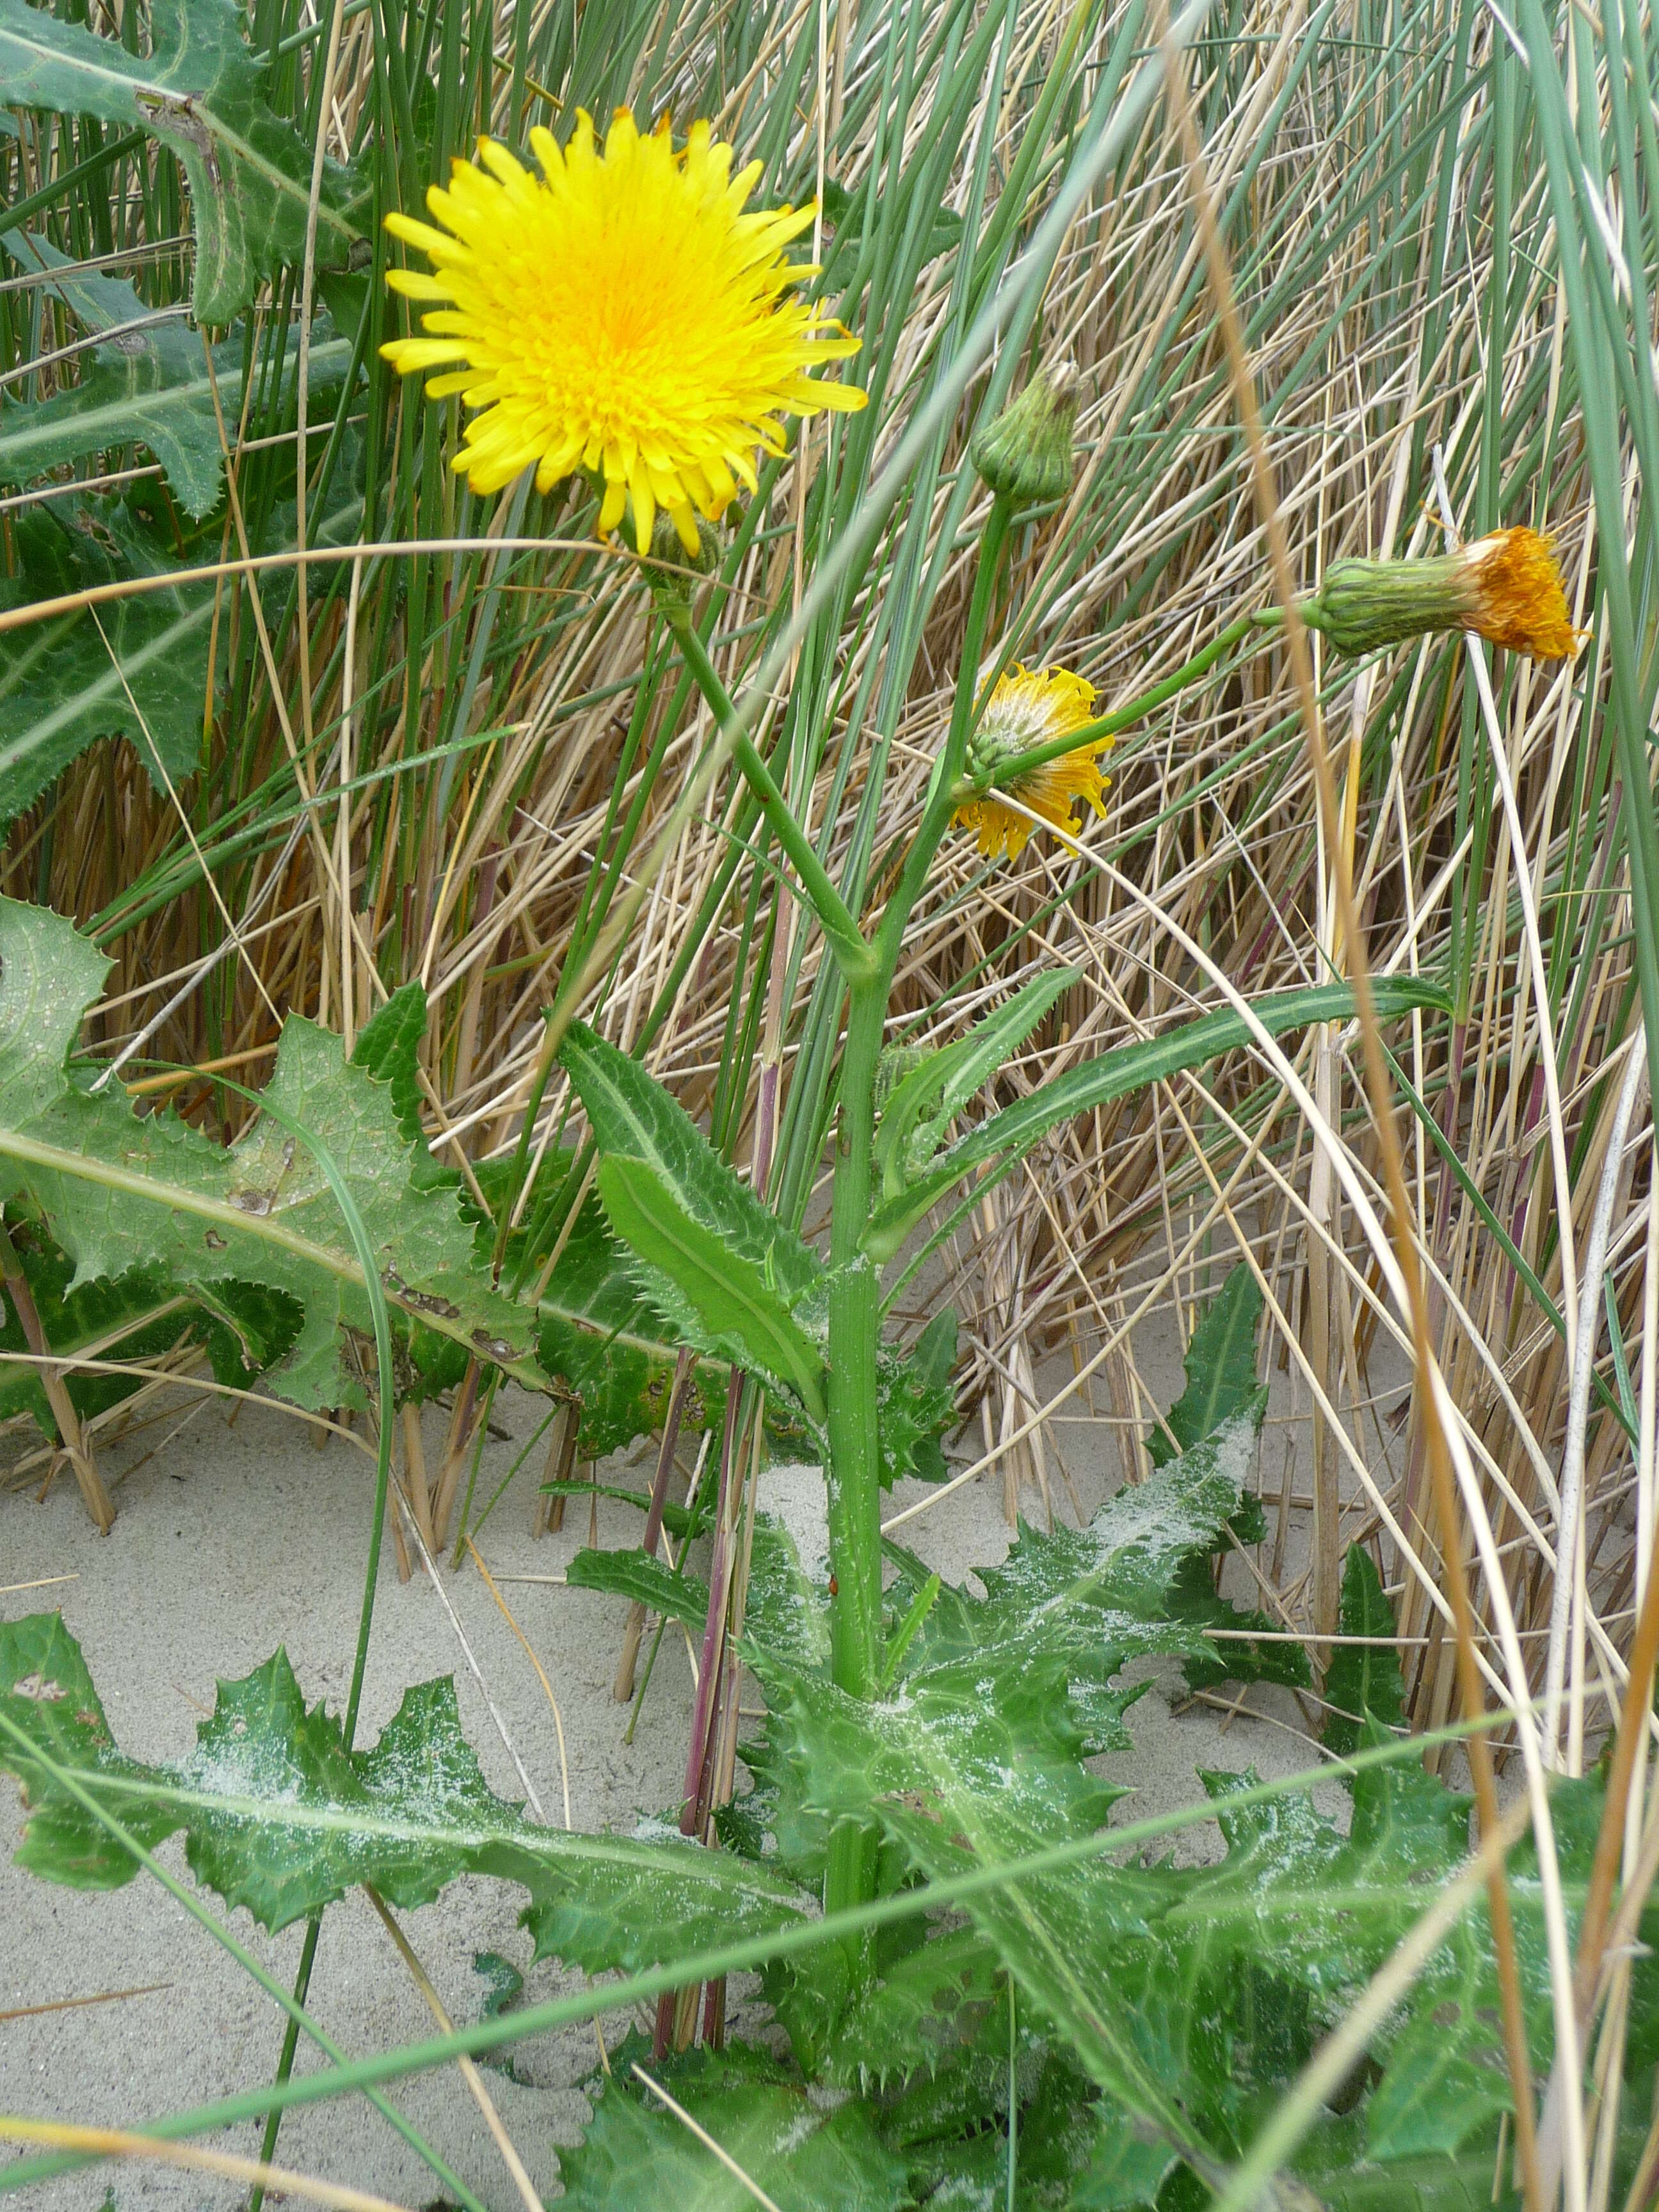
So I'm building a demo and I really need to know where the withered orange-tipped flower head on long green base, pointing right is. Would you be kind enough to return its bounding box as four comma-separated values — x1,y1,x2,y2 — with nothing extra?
1301,527,1583,661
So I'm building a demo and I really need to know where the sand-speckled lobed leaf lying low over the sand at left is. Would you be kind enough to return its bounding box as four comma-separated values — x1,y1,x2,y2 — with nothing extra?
0,1612,805,1973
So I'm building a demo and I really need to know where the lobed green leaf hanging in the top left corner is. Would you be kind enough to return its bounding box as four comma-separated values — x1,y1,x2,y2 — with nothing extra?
0,0,363,325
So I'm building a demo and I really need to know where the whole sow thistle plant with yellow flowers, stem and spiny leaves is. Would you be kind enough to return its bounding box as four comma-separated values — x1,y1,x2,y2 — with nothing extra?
0,113,1653,2212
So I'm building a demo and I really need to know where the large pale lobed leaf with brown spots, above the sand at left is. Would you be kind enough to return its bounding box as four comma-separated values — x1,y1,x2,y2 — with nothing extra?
0,901,540,1405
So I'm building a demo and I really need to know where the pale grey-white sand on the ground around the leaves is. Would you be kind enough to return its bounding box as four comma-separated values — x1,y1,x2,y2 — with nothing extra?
0,1343,1354,2212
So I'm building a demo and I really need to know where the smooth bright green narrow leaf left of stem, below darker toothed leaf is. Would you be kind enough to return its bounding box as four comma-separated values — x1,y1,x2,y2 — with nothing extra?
597,1153,825,1420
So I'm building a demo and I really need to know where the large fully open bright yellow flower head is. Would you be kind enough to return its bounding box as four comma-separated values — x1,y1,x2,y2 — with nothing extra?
380,108,865,553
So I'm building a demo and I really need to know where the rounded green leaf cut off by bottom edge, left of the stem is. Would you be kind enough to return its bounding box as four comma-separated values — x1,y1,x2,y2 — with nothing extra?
559,2044,911,2212
